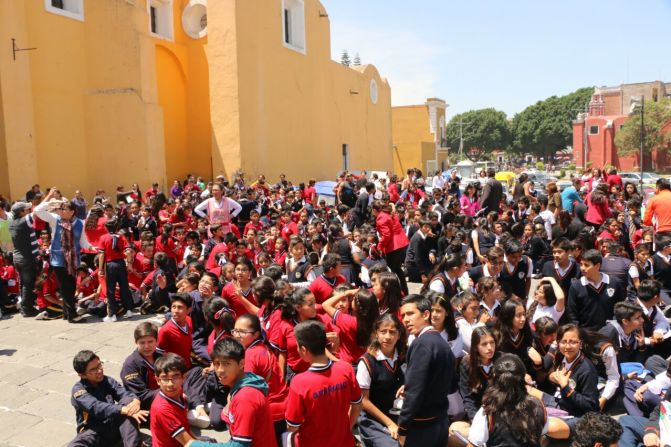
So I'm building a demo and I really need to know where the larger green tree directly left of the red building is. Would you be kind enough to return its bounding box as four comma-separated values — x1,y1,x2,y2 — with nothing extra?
509,87,594,160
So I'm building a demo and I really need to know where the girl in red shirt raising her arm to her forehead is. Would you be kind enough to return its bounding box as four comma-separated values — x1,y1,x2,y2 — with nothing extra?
322,289,380,366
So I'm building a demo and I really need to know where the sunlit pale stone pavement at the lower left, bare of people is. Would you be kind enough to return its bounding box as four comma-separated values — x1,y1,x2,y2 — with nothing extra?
0,315,228,447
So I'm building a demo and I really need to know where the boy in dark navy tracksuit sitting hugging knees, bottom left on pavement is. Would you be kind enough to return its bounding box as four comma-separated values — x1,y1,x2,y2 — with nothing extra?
70,350,149,447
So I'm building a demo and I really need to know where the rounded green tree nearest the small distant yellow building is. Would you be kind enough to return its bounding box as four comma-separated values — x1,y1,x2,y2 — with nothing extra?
445,108,510,162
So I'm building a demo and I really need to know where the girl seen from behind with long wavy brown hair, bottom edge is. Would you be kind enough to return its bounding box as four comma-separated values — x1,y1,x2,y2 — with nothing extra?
468,354,549,447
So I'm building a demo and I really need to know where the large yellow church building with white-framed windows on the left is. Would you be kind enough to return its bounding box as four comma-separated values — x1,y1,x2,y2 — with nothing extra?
0,0,392,199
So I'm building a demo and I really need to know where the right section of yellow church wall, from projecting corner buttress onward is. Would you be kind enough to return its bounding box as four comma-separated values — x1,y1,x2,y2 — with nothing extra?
208,0,391,180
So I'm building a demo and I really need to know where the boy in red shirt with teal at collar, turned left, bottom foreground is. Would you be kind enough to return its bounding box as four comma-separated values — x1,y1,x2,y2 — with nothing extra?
190,338,277,447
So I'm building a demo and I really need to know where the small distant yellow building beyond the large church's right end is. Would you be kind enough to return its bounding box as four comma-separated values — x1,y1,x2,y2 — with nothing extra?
391,98,448,175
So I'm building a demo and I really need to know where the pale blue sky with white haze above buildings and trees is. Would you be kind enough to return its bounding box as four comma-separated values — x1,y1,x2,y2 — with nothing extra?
322,0,671,118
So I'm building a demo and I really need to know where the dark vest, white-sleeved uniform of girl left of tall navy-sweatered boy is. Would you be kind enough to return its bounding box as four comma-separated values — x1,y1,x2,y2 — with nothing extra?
356,350,405,447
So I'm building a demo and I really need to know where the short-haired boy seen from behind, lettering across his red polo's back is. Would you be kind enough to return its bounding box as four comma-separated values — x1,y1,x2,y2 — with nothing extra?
285,320,363,447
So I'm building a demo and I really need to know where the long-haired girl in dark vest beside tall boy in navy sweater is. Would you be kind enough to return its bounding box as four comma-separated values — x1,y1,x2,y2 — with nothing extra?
356,314,406,447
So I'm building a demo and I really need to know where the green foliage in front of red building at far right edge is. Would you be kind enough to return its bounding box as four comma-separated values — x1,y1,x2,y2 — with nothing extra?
615,98,671,155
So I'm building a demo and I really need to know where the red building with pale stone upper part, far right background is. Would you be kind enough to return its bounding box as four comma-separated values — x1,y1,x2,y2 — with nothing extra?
573,81,671,171
